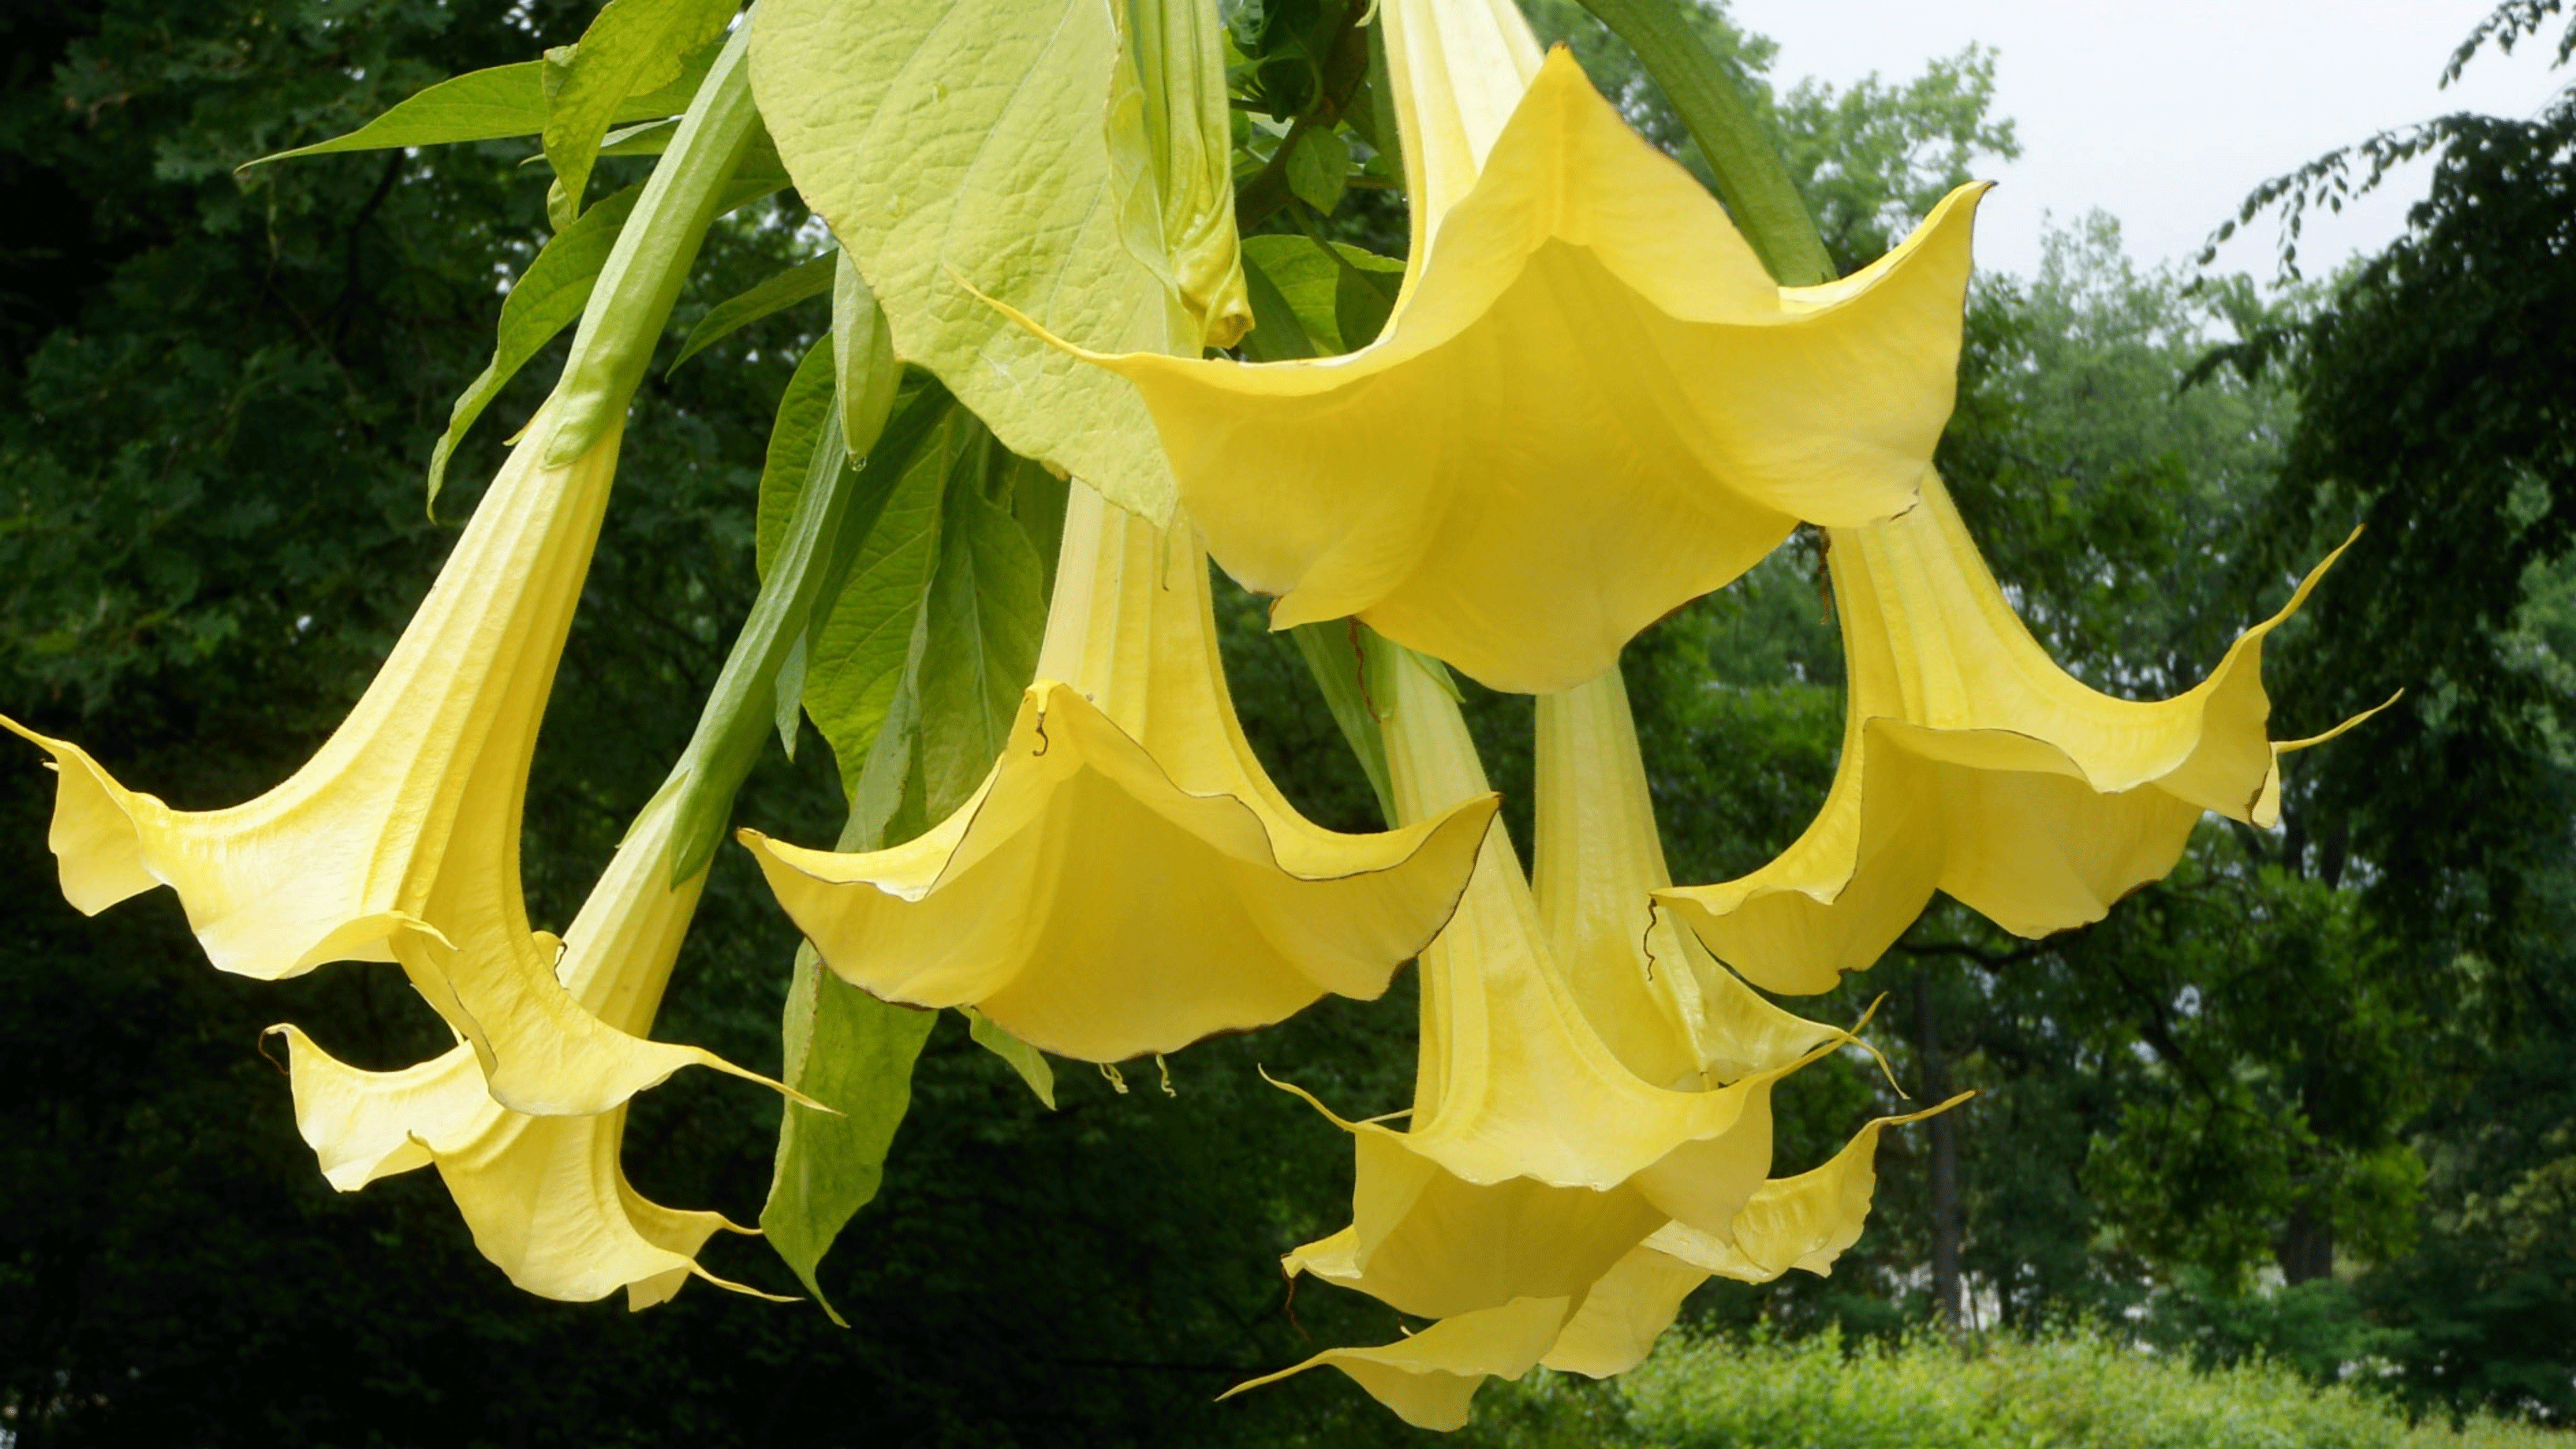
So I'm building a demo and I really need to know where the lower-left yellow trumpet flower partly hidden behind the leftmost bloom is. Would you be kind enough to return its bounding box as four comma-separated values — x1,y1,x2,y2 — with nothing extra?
273,789,765,1307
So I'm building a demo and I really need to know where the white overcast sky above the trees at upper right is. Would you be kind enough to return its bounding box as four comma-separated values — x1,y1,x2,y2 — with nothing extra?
1728,0,2576,278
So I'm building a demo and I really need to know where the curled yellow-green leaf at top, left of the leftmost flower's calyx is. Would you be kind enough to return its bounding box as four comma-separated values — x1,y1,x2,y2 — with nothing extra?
541,0,737,227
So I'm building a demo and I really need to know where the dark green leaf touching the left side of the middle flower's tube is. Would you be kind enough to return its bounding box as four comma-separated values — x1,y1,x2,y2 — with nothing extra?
922,441,1046,804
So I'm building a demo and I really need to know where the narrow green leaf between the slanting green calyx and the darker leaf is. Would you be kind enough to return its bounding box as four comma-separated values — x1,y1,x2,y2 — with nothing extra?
804,407,974,794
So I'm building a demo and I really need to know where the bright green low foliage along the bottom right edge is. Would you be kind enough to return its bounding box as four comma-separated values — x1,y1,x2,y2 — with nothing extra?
1465,1331,2576,1449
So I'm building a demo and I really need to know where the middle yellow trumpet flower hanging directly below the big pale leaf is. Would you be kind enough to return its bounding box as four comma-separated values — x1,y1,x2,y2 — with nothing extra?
742,482,1494,1062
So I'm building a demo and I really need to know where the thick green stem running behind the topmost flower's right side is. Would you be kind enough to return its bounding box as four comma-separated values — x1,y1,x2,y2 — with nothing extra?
1585,0,1837,286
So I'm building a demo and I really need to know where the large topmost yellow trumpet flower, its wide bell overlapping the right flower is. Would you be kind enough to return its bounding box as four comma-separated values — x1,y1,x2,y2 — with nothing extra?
1095,33,1978,691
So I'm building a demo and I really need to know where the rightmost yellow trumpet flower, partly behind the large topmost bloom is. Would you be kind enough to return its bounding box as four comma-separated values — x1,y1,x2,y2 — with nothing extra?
1656,474,2360,992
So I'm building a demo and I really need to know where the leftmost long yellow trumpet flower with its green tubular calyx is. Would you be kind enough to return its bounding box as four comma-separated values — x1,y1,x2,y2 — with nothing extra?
0,22,760,1114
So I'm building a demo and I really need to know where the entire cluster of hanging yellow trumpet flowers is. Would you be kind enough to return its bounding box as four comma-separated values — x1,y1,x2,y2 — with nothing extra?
0,0,2331,1428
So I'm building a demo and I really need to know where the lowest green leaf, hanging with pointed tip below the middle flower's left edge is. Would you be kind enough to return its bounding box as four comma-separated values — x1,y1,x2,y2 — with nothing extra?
760,943,938,1328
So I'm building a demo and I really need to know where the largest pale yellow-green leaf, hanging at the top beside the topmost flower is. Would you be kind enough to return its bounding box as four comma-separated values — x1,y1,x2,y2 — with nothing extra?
752,0,1198,518
